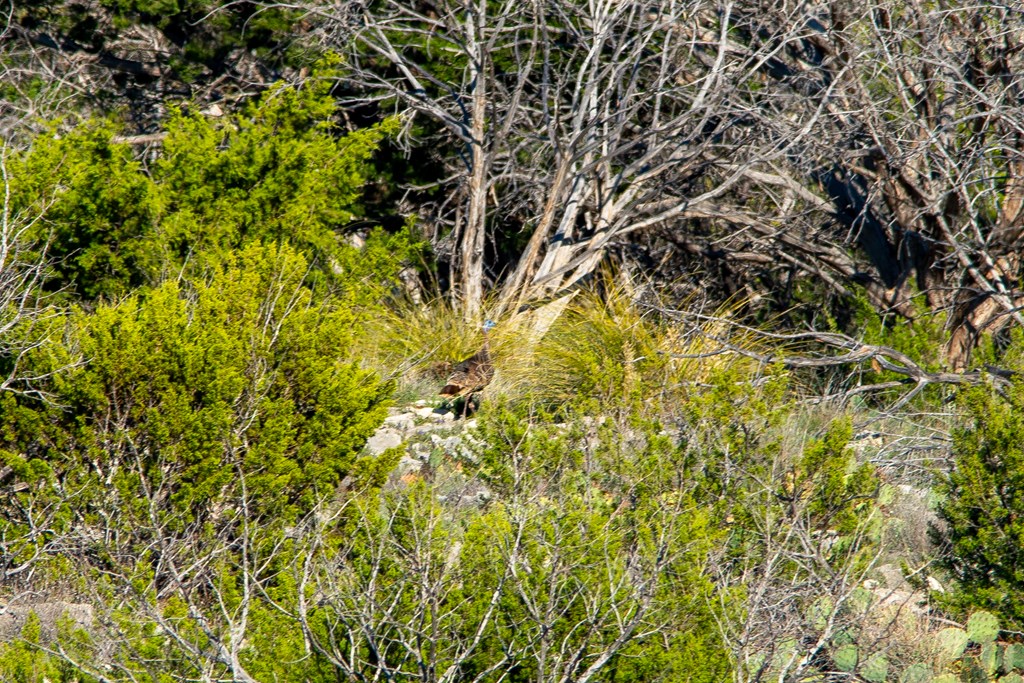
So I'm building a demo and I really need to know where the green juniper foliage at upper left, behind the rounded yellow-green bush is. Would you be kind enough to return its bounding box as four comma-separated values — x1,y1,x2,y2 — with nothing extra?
10,72,414,299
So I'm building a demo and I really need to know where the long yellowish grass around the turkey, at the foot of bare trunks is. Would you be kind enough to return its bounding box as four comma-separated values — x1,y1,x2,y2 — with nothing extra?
359,279,778,410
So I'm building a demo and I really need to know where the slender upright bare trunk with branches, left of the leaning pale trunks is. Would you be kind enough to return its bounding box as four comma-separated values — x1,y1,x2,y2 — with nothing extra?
311,0,545,318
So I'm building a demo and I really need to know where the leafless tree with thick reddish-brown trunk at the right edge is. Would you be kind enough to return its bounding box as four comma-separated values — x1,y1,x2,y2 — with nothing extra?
716,2,1024,369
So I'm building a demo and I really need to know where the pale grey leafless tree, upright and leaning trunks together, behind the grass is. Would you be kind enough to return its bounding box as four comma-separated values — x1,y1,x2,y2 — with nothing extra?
311,2,785,315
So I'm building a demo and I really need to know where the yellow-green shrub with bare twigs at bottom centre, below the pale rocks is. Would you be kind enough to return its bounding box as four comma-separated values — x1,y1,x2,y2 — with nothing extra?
335,401,731,683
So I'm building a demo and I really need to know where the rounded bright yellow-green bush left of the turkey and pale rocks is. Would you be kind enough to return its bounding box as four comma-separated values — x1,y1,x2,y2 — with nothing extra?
0,246,389,548
